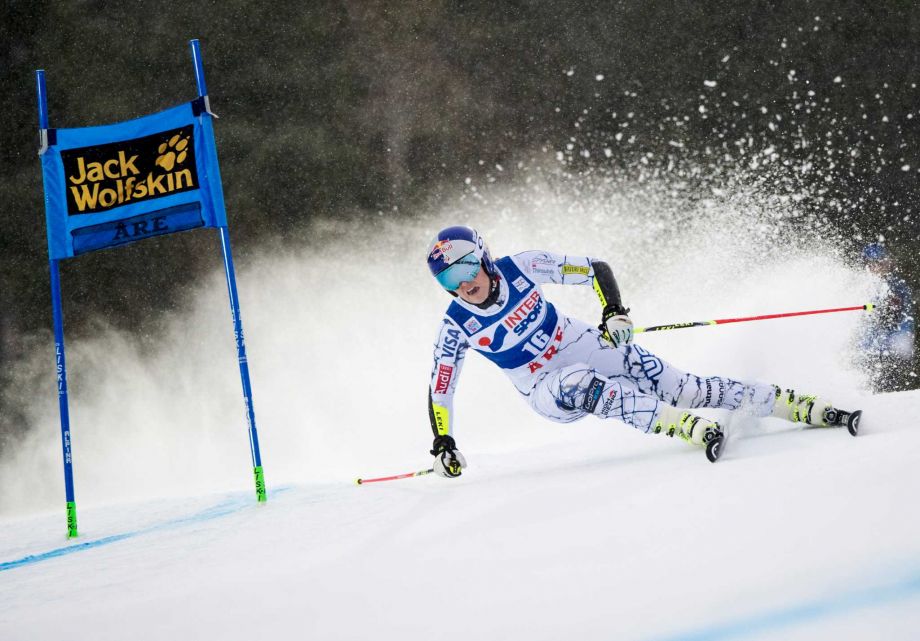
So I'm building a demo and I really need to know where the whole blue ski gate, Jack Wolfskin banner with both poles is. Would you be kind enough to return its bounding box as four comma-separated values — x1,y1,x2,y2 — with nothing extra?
36,40,267,538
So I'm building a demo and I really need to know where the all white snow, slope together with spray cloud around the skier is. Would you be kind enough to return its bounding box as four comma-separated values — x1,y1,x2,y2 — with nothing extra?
0,182,920,641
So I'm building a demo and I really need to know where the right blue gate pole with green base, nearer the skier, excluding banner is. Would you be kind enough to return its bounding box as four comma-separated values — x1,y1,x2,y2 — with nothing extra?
189,39,267,502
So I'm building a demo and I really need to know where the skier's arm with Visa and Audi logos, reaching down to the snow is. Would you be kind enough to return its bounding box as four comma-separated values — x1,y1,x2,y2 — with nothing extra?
428,316,469,477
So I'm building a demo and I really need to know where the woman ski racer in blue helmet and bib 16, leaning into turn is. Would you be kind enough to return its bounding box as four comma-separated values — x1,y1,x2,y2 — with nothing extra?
428,227,855,477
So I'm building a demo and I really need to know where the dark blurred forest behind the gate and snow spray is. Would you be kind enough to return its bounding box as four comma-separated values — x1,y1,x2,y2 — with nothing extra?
0,0,920,445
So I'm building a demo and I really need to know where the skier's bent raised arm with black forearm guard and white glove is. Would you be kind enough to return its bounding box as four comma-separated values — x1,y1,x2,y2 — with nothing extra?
512,251,633,347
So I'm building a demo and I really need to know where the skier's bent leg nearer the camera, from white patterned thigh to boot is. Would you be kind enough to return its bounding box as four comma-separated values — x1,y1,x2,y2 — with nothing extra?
529,364,721,445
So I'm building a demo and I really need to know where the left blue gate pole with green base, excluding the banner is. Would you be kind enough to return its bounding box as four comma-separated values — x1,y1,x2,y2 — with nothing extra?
35,69,77,539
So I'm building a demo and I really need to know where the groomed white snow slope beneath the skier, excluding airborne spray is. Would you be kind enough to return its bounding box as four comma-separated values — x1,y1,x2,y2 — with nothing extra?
0,392,920,641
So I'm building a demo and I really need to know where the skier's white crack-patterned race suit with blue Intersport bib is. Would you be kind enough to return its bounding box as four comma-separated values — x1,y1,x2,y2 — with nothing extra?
429,251,775,436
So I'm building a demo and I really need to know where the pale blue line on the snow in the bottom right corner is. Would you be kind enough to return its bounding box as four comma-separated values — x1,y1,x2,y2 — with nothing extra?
655,575,920,641
